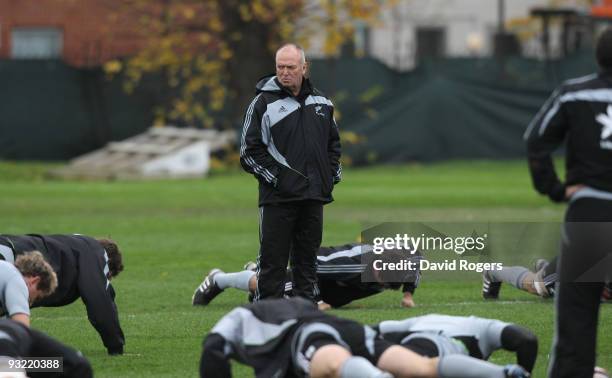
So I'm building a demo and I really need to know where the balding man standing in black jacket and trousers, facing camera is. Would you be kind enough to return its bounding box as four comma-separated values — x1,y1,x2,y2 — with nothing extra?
240,44,342,301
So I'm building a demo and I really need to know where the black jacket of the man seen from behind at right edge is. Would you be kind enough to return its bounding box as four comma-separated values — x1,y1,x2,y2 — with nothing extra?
525,72,612,202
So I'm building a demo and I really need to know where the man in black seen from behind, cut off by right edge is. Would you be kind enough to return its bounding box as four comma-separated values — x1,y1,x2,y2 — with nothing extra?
525,28,612,378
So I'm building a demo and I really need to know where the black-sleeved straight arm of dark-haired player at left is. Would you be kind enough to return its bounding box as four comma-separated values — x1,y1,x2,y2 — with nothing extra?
77,253,125,355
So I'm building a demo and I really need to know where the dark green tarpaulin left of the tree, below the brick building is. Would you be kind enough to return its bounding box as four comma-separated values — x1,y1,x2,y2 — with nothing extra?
0,60,154,160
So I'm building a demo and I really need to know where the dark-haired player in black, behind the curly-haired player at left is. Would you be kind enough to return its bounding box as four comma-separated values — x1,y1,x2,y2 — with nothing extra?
0,235,125,355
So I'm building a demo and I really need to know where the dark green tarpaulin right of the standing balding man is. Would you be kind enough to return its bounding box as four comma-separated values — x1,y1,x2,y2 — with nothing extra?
313,53,596,164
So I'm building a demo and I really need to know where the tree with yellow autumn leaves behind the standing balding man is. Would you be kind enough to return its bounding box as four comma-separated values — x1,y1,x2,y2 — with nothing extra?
105,0,394,127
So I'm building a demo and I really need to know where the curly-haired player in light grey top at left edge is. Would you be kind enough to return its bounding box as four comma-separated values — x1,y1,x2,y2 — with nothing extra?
0,251,57,328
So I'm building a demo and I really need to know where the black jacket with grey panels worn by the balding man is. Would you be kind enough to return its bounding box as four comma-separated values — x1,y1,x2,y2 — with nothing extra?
240,76,342,206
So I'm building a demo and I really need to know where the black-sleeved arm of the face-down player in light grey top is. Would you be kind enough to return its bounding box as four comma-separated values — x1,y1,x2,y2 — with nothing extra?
501,324,538,372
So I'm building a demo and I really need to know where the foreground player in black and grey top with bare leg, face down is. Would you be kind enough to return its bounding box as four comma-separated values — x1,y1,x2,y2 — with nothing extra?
200,298,529,378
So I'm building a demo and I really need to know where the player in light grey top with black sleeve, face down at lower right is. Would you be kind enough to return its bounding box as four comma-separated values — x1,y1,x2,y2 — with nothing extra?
373,314,538,372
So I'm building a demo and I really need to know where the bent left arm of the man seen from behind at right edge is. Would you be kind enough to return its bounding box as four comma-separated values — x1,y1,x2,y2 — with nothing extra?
524,89,568,202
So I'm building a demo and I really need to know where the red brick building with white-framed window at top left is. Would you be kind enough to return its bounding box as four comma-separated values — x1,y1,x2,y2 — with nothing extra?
0,0,145,67
